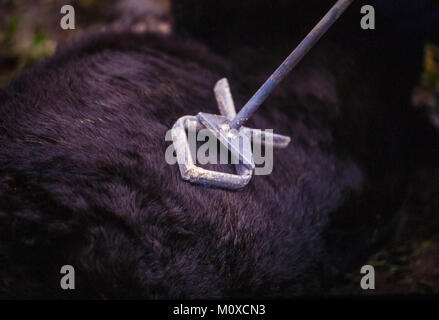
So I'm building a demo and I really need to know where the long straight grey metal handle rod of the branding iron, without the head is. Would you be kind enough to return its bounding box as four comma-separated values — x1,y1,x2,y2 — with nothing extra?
230,0,354,129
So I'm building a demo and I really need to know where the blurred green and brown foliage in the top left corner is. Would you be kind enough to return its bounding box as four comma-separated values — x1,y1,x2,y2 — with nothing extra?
0,0,108,85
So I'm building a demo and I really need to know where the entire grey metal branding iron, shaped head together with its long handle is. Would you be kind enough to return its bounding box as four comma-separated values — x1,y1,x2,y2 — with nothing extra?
172,0,353,190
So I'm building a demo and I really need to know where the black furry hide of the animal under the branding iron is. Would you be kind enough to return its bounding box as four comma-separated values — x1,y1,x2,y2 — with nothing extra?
0,1,434,298
